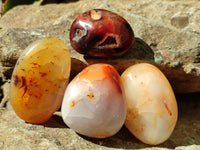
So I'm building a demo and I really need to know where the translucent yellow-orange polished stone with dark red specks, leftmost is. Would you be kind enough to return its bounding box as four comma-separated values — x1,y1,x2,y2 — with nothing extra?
10,37,71,124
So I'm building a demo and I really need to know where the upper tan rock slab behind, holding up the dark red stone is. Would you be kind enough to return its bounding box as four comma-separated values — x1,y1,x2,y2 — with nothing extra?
0,0,200,93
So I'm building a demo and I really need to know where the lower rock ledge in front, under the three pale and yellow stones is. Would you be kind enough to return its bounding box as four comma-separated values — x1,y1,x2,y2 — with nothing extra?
0,94,200,150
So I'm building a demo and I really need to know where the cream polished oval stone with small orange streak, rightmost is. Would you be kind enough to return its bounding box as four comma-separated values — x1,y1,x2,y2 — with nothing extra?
121,63,178,145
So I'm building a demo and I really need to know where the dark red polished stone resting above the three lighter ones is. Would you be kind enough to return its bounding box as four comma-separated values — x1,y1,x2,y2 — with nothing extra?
70,9,134,57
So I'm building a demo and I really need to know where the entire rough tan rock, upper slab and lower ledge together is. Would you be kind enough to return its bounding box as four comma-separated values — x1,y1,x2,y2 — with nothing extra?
0,0,200,150
